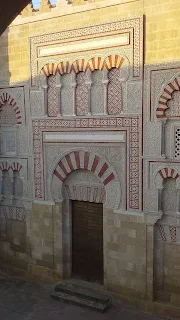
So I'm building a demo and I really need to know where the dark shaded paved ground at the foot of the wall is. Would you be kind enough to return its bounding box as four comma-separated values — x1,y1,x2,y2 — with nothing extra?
0,274,165,320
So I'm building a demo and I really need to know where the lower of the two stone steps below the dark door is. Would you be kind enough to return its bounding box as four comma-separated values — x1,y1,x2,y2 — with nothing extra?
51,292,110,313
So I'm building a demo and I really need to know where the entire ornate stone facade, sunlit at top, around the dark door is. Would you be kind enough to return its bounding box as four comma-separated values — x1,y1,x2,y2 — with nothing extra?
0,0,180,319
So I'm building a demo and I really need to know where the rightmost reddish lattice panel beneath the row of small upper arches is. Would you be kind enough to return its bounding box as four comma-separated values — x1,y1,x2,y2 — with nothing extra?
108,68,121,114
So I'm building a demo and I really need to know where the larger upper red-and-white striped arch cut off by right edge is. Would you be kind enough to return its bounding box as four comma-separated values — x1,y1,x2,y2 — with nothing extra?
156,76,180,119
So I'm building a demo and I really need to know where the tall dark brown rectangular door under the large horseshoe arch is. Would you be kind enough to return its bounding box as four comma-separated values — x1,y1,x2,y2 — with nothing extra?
72,201,104,284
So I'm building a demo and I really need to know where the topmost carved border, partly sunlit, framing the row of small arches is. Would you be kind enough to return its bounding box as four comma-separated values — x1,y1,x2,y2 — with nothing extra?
31,17,143,86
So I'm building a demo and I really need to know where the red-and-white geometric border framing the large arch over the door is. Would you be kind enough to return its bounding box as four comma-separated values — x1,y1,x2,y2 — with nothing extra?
33,117,141,210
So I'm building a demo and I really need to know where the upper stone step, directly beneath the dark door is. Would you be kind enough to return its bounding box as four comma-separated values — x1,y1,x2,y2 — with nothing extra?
55,283,111,305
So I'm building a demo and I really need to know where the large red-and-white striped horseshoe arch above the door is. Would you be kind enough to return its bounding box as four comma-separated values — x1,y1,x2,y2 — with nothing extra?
50,149,121,209
